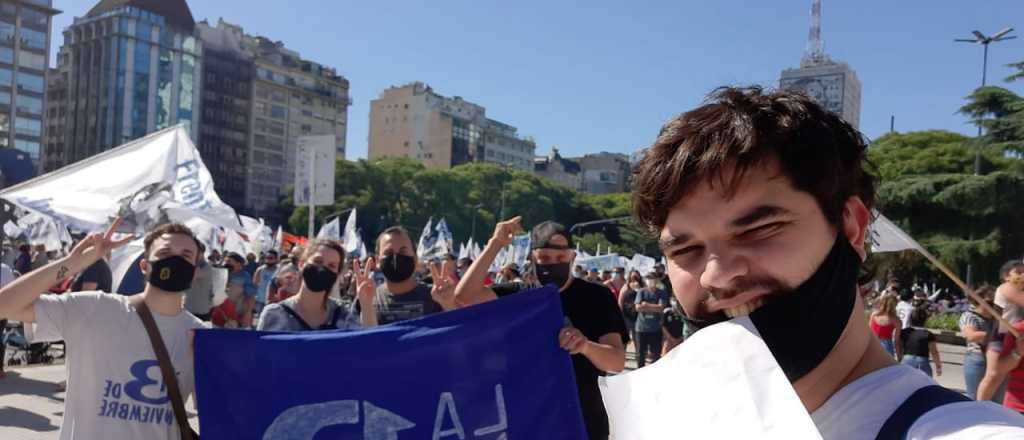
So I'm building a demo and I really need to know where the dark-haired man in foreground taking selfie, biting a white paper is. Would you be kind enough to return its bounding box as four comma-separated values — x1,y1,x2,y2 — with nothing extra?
632,88,1024,439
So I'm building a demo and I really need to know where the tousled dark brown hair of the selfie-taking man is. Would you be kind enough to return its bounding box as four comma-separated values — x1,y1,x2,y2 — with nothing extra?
632,87,876,233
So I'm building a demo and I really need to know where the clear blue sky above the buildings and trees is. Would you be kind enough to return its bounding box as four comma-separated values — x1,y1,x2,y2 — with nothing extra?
53,0,1024,160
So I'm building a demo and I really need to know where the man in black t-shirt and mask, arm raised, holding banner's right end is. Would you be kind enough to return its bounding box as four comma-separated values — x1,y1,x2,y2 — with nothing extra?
455,217,629,439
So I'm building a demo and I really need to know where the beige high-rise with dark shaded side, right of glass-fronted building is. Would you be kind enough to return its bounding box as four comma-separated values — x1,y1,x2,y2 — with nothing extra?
198,19,350,223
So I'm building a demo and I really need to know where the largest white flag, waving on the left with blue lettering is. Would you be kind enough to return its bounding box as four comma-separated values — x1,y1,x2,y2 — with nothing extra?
0,125,242,233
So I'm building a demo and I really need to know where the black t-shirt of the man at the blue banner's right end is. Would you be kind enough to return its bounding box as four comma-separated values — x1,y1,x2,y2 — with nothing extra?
490,278,630,438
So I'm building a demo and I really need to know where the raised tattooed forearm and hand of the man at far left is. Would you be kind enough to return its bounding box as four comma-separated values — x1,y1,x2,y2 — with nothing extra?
0,218,133,322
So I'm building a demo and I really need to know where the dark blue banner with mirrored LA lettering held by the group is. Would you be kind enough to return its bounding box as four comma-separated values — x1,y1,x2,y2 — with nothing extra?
196,288,587,440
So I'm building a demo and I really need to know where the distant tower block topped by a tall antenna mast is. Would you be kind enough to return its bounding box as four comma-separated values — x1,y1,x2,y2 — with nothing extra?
778,0,860,128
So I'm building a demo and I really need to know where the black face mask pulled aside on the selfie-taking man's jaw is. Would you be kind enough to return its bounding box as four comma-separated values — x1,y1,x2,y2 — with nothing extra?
684,234,861,383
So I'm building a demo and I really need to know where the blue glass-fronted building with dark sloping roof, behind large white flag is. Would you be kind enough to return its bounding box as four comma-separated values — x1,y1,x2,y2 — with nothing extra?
45,0,203,169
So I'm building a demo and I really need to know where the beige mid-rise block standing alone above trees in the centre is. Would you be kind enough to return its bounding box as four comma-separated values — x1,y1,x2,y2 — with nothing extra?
369,82,537,171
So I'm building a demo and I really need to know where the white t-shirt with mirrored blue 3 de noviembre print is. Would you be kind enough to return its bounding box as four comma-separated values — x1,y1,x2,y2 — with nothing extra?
30,292,203,440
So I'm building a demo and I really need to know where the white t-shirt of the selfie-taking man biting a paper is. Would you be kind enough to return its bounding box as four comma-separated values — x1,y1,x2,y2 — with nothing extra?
811,365,1024,440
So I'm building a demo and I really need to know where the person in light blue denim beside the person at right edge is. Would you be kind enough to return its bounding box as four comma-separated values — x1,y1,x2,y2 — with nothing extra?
959,287,1005,400
